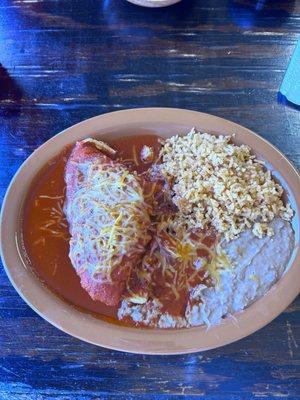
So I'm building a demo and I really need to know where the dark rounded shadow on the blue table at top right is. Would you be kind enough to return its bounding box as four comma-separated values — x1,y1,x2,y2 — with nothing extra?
228,0,295,29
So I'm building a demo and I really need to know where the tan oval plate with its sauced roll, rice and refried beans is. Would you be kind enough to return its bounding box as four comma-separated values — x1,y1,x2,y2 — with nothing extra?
1,108,300,354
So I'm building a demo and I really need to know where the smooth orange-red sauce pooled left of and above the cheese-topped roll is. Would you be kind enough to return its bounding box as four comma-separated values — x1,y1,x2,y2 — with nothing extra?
21,135,160,323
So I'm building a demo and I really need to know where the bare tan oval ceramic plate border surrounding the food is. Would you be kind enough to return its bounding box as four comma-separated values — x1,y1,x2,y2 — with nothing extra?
1,108,300,354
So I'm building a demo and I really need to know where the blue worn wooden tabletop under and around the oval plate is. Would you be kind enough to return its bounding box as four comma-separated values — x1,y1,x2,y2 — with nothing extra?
0,0,300,400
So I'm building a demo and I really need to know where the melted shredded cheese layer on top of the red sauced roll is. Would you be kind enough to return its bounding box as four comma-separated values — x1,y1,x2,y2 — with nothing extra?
65,155,150,280
